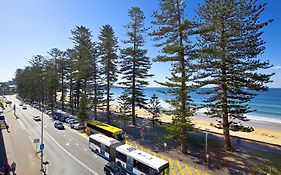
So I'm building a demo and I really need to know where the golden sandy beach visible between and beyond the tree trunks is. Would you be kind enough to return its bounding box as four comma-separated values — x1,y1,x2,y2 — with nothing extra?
109,104,281,146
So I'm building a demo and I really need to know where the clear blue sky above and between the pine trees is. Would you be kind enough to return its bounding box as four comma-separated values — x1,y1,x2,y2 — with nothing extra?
0,0,281,88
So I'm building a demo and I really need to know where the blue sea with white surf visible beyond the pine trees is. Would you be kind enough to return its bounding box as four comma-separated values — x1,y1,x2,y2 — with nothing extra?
112,87,281,123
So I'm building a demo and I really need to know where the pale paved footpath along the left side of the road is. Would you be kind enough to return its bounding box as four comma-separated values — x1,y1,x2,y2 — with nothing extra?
0,106,41,175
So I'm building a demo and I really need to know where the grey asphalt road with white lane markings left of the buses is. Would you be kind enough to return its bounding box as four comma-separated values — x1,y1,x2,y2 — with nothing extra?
7,96,106,175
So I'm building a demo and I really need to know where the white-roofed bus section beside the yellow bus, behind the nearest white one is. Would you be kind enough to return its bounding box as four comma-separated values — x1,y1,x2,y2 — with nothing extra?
89,134,123,161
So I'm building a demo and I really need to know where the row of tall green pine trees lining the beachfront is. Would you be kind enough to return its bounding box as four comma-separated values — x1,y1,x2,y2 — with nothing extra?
16,0,273,153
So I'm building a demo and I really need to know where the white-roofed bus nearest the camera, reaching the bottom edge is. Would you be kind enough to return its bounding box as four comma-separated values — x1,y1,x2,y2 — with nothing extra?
115,144,169,175
